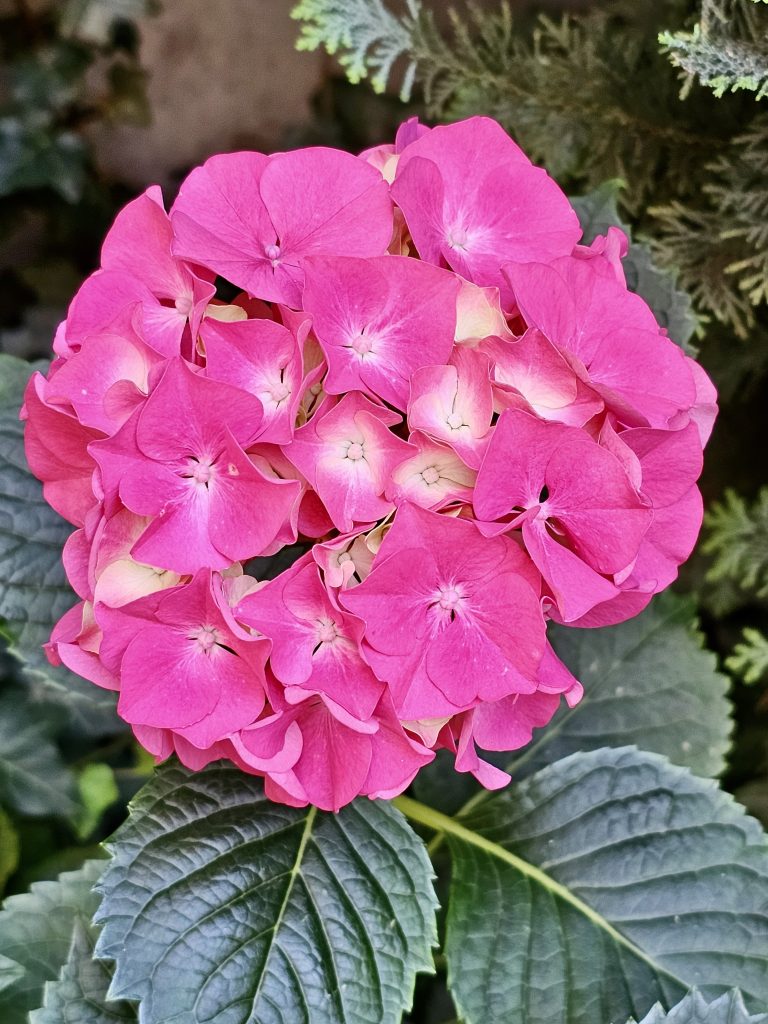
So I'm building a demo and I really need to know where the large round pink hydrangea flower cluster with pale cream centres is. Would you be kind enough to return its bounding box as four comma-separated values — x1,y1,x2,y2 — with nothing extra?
23,118,716,809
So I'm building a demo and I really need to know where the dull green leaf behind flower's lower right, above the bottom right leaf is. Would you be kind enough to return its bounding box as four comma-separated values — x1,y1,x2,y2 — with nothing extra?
507,593,733,778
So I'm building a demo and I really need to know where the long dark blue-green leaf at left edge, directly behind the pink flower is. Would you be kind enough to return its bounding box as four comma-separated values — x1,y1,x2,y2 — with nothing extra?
0,354,118,733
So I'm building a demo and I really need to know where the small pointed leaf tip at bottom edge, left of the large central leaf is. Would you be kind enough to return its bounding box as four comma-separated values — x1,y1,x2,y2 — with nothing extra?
30,919,137,1024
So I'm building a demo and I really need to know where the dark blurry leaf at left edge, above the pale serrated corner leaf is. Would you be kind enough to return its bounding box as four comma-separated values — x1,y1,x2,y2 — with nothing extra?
0,690,77,817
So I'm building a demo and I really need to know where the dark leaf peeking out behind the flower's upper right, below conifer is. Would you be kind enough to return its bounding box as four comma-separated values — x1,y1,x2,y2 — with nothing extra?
570,186,696,355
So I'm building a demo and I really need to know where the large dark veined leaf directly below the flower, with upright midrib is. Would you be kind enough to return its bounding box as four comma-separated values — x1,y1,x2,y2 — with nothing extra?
97,763,436,1024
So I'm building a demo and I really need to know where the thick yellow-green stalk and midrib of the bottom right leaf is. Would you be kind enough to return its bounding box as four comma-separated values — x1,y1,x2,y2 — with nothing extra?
392,797,688,989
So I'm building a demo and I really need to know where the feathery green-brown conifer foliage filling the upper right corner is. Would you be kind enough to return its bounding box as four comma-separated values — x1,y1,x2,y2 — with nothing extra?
293,0,768,350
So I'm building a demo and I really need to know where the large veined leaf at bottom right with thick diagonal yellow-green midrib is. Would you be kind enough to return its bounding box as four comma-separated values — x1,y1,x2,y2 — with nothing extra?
396,748,768,1024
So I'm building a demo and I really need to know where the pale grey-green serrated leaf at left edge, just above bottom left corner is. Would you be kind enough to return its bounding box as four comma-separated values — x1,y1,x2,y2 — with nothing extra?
0,860,104,1024
